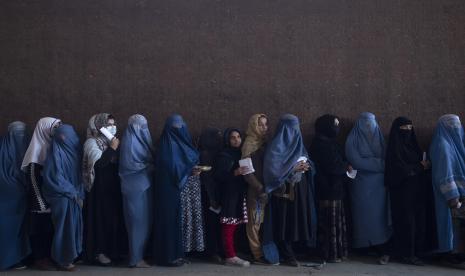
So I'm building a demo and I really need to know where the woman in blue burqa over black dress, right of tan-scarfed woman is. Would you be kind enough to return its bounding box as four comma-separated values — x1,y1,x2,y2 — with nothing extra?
263,114,317,266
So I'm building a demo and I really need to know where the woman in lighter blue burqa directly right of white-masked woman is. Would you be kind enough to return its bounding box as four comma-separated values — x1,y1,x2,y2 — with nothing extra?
119,114,154,268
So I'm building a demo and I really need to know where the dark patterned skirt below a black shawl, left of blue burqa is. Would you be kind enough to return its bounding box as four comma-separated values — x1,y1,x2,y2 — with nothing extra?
318,200,348,260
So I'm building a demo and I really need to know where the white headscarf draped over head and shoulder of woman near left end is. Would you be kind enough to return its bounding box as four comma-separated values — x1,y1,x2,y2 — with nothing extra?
21,117,61,171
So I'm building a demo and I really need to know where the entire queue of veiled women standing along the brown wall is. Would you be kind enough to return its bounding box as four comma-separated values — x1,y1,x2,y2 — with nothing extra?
0,113,465,271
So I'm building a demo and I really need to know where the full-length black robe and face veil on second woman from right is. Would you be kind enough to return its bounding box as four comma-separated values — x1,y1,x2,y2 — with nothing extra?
385,117,434,258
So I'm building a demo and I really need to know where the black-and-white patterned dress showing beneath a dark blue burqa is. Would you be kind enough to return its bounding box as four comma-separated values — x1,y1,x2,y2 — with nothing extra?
181,176,205,252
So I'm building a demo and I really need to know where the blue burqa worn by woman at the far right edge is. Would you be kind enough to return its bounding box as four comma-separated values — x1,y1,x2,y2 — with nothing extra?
430,115,465,252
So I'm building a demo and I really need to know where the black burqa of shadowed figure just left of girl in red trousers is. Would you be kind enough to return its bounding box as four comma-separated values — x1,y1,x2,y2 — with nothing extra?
199,127,223,256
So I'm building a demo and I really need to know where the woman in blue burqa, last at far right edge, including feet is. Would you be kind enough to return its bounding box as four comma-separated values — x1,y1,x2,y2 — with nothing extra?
430,114,465,264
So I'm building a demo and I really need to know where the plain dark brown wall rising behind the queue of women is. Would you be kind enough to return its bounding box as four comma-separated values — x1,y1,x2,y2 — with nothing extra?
0,0,465,149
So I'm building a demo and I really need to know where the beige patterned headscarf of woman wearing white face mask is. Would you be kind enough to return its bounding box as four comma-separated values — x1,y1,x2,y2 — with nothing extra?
82,113,110,192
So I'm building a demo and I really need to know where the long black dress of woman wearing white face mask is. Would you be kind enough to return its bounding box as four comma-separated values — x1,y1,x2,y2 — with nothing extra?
85,147,128,262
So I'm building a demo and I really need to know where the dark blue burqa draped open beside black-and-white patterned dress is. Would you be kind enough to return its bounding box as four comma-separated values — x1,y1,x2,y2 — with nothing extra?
153,115,200,266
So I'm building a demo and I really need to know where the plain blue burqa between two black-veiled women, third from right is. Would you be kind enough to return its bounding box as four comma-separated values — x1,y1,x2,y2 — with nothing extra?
345,112,392,248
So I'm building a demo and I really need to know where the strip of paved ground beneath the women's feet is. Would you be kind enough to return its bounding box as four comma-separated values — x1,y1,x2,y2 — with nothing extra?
0,257,465,276
